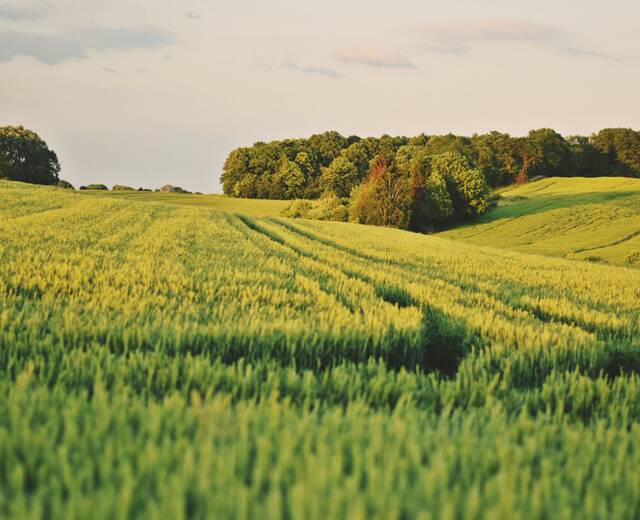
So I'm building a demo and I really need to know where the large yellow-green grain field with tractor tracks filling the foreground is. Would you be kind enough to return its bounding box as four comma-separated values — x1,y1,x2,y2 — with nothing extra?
0,182,640,519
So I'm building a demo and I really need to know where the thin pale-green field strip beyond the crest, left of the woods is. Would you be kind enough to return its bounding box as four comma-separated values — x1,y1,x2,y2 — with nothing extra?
78,190,290,217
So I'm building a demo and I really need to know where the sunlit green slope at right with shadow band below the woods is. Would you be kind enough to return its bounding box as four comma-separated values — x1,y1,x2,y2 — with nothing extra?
440,177,640,264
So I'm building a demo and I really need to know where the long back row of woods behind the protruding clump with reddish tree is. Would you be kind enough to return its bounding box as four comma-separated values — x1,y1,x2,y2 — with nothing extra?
221,128,640,203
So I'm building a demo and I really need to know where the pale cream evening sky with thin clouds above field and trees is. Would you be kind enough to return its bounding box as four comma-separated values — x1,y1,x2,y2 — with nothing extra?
0,0,640,193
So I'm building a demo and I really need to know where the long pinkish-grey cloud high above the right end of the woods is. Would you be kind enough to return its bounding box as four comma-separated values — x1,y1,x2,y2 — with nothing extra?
421,20,569,54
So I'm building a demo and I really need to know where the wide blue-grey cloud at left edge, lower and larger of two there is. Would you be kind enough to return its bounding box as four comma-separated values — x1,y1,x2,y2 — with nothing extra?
0,27,175,65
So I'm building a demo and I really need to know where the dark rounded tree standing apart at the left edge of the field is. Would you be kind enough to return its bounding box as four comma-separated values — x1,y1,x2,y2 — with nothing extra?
0,126,60,184
